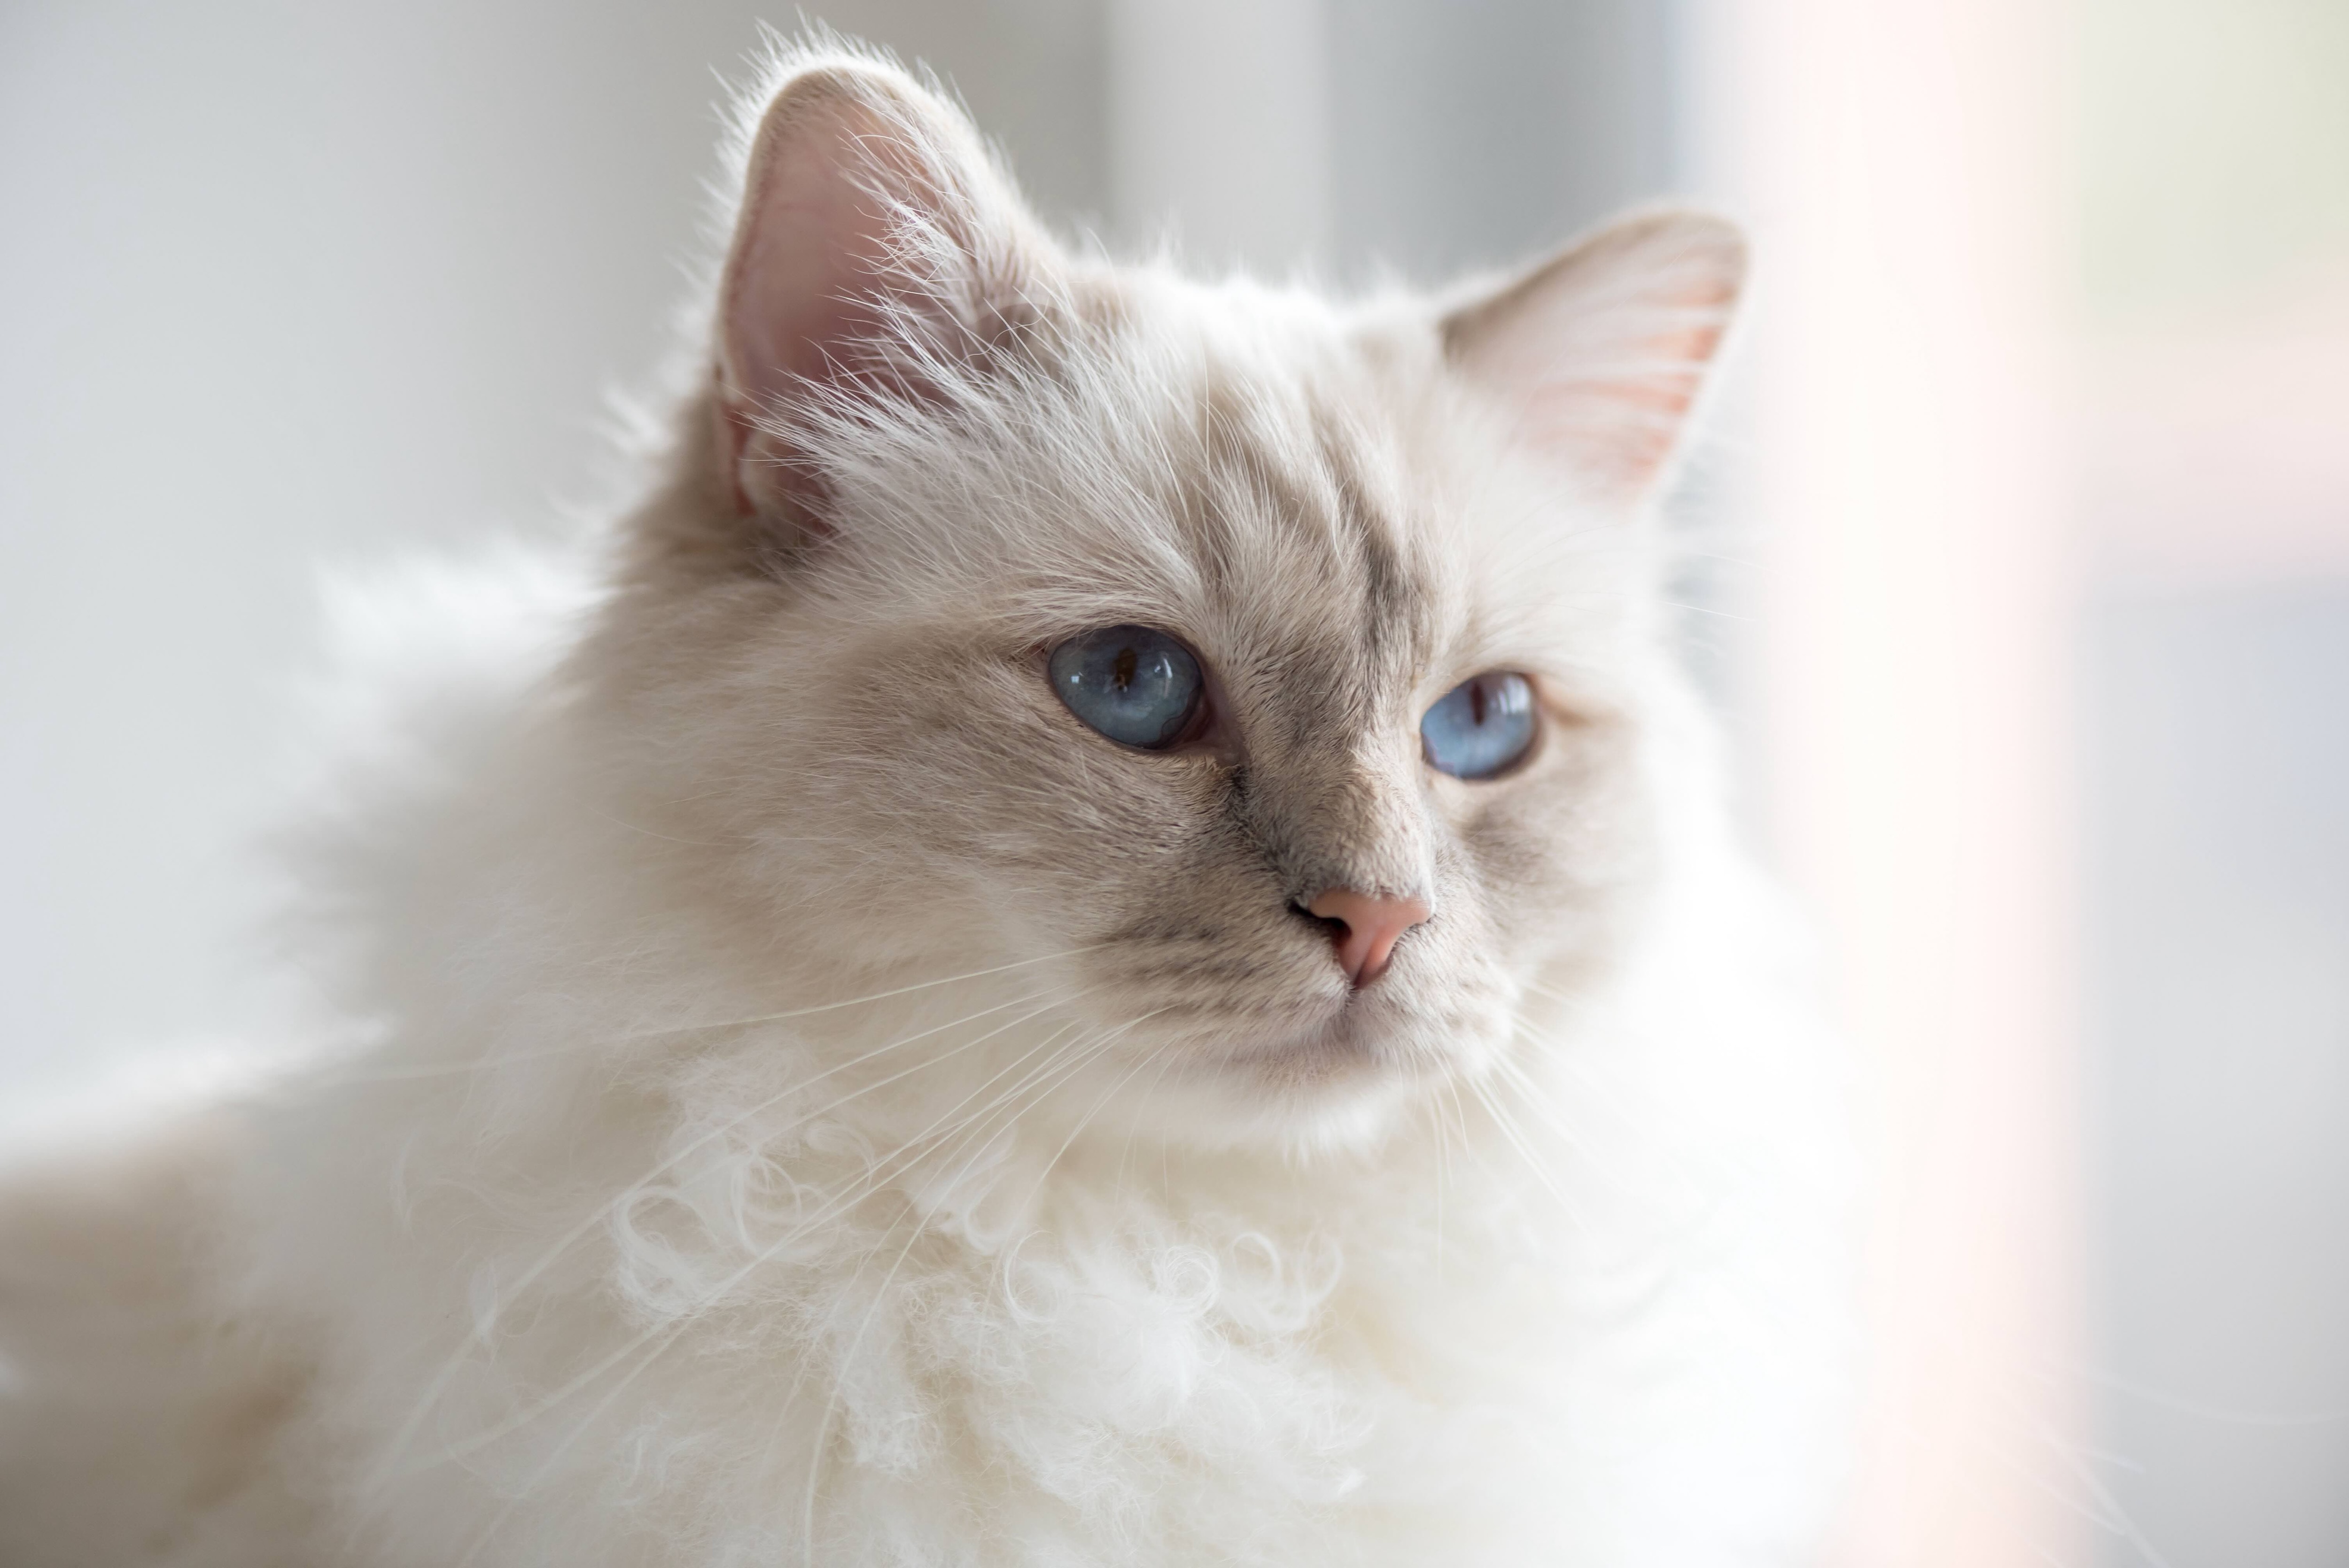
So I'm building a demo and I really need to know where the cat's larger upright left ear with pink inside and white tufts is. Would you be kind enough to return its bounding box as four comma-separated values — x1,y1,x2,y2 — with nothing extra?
712,54,1055,535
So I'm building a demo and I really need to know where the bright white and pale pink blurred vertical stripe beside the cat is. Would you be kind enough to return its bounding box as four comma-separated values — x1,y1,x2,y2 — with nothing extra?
1696,0,2086,1568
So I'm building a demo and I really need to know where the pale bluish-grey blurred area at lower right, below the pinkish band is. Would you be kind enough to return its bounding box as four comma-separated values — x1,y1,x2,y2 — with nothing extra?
2084,591,2349,1568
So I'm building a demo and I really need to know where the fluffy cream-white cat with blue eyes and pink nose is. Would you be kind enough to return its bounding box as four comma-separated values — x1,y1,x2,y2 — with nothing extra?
0,35,1851,1568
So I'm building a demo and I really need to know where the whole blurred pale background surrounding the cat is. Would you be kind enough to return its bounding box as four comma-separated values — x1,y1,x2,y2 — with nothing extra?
0,0,2349,1568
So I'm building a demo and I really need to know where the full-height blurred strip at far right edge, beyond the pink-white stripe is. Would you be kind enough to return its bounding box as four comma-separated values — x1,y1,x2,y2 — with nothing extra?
2074,0,2349,1568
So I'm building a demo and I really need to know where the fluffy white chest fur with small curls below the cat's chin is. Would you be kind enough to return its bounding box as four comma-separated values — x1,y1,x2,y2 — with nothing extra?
221,807,1832,1568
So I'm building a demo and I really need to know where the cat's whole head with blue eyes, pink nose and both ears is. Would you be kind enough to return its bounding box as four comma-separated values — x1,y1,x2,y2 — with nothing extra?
578,52,1743,1139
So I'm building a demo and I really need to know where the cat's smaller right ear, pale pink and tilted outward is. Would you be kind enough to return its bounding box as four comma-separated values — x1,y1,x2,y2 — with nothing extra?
1442,211,1745,500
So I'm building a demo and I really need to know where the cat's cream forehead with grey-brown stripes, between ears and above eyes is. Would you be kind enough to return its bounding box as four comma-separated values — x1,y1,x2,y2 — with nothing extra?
991,284,1635,678
